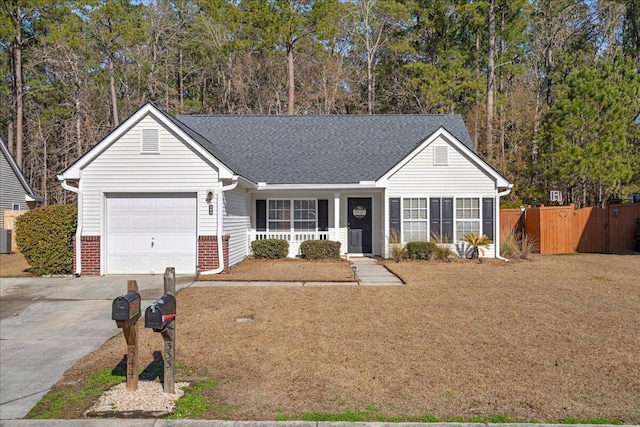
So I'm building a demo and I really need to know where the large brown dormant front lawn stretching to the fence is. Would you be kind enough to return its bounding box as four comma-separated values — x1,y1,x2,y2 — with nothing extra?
36,255,640,424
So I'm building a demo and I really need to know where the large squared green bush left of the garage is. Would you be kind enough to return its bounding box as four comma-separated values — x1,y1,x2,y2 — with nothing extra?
16,205,78,275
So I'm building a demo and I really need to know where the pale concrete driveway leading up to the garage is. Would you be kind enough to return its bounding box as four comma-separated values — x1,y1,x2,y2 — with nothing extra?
0,275,195,420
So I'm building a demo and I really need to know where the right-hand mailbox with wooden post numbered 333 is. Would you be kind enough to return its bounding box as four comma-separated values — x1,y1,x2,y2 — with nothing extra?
144,267,176,394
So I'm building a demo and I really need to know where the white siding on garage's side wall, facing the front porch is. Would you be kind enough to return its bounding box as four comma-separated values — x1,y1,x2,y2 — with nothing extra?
222,188,251,266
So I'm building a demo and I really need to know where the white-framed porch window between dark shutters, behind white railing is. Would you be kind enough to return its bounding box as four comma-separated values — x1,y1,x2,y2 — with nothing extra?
268,200,317,231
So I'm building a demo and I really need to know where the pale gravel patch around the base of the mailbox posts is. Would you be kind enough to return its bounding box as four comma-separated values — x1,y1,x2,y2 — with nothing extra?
87,381,189,416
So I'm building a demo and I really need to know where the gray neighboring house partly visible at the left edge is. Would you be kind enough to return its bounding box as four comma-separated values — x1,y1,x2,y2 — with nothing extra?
0,138,43,228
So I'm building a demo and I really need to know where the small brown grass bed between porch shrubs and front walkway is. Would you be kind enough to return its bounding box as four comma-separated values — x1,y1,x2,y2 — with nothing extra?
198,258,353,282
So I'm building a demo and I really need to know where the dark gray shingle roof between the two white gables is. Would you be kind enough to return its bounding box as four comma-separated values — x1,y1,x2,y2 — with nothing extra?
174,115,475,184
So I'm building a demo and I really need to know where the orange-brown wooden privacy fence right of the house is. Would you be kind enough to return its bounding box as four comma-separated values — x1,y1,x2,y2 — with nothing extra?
500,203,640,254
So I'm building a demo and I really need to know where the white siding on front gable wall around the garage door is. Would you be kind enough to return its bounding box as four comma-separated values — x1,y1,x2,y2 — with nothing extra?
81,116,218,236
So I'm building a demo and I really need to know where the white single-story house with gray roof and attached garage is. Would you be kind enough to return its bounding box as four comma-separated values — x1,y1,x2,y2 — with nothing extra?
58,104,512,274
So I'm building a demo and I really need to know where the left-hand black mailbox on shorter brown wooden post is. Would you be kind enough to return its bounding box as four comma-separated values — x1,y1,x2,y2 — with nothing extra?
111,280,141,391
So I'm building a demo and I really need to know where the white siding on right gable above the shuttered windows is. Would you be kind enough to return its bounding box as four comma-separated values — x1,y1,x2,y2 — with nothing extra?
387,138,496,197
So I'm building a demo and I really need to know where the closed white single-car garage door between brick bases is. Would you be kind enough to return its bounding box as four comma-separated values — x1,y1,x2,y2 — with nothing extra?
106,193,197,274
